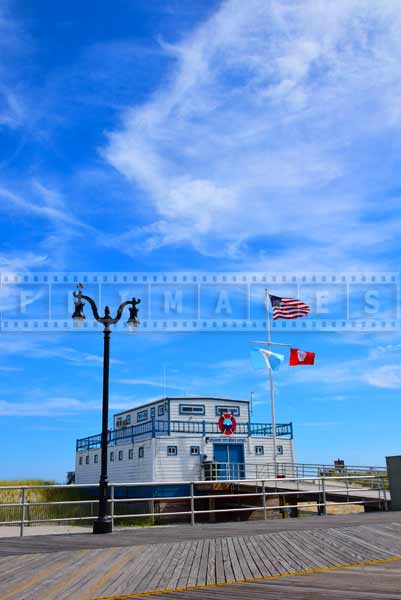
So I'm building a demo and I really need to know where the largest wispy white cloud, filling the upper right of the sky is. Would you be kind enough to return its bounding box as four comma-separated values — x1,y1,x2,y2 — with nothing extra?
103,0,401,267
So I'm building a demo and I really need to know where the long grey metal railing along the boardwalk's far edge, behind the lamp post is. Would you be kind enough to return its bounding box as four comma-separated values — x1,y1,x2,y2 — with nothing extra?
0,475,389,536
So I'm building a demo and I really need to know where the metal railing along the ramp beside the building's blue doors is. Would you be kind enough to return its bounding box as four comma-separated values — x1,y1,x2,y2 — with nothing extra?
201,459,387,481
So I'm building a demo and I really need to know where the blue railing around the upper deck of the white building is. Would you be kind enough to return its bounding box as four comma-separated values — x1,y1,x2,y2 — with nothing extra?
76,419,293,452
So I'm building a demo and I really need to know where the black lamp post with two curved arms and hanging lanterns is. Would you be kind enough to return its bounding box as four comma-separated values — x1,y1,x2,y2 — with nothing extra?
72,283,140,533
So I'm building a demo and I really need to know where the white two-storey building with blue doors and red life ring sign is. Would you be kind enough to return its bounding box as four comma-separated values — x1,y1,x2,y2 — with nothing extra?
75,397,294,483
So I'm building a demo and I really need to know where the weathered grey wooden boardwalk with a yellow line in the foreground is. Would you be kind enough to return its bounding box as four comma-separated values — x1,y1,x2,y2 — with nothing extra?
0,513,401,600
